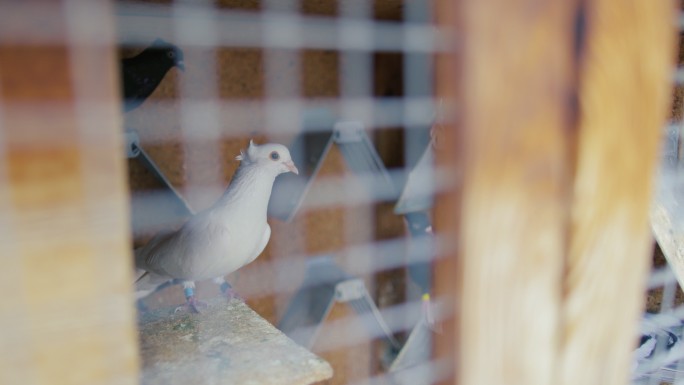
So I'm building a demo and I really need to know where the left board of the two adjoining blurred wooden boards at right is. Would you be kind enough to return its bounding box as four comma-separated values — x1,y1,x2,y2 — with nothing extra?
435,0,579,385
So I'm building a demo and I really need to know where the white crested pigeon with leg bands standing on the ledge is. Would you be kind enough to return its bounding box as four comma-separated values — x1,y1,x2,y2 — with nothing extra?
135,141,299,312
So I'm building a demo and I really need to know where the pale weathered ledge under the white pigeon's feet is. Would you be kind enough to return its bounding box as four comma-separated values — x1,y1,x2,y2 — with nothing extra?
138,298,333,385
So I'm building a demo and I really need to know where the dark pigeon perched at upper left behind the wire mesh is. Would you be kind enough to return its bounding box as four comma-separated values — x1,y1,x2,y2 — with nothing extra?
121,39,185,111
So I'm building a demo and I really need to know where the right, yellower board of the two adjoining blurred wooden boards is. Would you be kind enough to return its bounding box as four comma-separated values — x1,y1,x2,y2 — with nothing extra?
556,0,678,385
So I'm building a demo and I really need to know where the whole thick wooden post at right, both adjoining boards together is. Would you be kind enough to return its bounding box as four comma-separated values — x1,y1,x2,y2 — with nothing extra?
436,0,675,385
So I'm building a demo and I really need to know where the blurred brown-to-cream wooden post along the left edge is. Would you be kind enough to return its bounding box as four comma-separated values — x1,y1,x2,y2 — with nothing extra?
0,1,138,385
